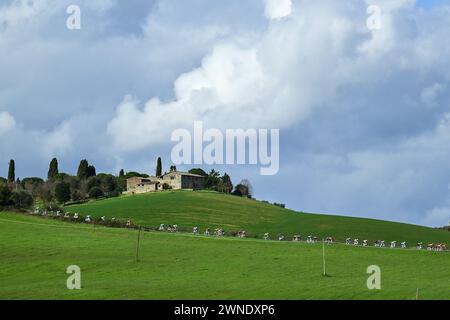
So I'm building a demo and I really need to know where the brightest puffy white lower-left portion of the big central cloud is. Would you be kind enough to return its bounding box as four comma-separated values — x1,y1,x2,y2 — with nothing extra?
107,44,284,151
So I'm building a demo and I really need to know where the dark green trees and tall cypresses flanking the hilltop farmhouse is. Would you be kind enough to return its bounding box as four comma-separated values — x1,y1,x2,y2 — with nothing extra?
0,157,253,210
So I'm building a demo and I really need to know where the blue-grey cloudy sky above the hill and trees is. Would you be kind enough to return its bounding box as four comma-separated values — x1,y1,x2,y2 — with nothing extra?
0,0,450,226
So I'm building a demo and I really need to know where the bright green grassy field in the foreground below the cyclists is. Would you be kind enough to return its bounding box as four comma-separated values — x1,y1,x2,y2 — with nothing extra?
0,212,450,299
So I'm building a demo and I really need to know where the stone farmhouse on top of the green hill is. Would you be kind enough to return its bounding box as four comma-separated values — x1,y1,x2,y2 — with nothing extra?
127,171,205,194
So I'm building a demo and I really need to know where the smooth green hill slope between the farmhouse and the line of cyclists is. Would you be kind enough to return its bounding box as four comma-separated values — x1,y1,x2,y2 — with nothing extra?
66,191,450,245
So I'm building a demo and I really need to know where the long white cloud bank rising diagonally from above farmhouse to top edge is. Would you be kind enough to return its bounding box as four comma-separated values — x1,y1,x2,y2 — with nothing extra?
108,1,426,151
